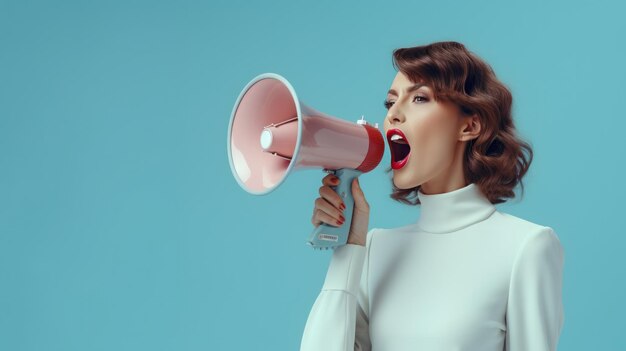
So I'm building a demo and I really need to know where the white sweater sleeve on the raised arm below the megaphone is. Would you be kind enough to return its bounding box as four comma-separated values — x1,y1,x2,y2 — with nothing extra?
300,229,374,351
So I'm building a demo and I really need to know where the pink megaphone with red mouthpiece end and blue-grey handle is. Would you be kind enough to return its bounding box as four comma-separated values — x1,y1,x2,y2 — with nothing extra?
227,73,385,249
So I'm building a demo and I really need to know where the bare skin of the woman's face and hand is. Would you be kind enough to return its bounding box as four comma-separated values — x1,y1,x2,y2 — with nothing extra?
311,72,480,246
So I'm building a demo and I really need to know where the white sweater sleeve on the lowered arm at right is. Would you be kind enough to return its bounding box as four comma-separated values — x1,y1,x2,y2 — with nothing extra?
505,227,564,351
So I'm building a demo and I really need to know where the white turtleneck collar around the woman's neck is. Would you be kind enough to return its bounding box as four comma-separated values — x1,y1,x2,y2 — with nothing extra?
416,183,496,234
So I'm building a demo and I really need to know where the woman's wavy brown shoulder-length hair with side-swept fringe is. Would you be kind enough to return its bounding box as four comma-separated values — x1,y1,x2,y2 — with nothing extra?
386,41,533,205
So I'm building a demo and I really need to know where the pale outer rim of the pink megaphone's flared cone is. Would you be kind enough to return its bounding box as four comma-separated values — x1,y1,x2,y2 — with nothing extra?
226,72,302,195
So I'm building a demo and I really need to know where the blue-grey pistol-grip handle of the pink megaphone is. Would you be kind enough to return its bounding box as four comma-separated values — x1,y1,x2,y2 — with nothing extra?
307,168,363,249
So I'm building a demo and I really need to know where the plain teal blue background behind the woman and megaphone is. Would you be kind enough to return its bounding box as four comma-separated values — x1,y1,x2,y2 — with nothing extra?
0,0,626,350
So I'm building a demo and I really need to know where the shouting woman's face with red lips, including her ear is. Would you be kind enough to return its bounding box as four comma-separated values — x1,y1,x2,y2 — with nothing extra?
384,71,480,194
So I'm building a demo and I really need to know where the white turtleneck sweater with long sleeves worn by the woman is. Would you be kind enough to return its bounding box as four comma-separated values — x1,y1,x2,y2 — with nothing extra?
301,183,564,351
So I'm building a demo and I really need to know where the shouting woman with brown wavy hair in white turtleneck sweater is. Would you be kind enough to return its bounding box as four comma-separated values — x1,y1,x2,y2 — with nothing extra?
301,42,564,351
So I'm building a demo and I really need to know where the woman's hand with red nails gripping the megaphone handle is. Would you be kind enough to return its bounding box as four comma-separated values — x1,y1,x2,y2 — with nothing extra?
311,174,370,246
